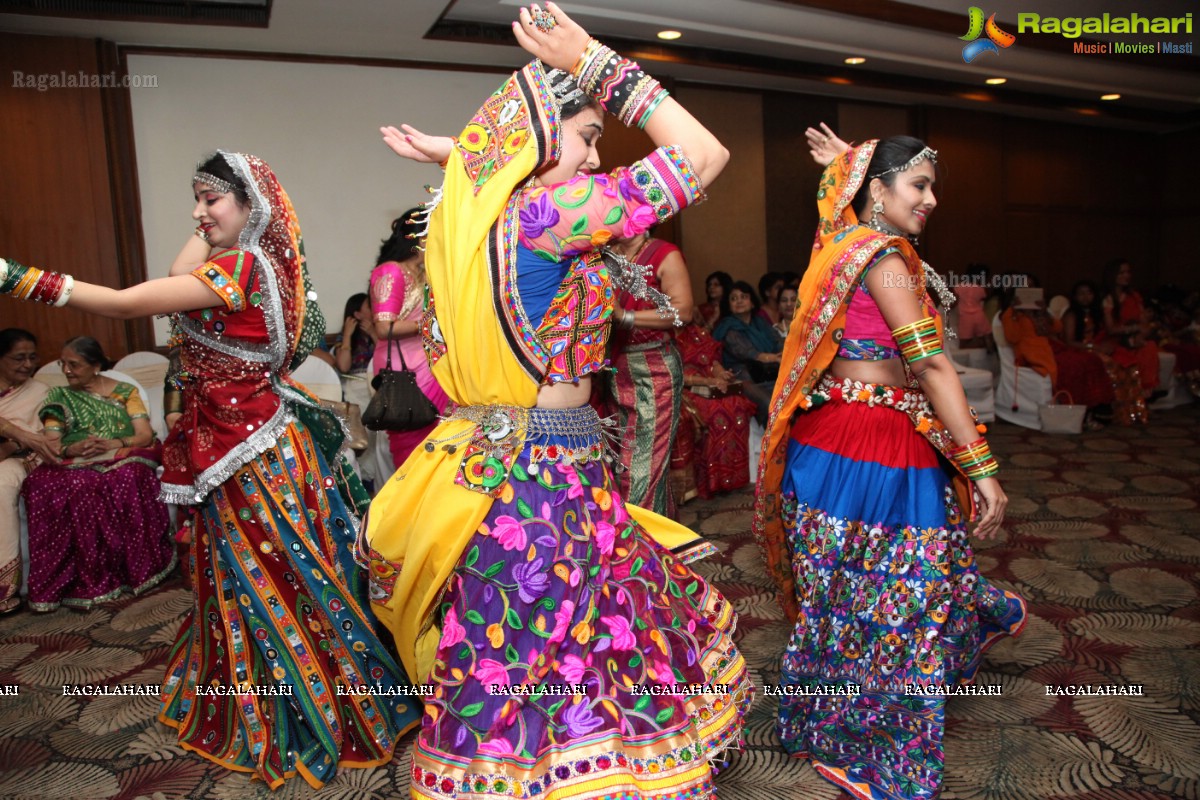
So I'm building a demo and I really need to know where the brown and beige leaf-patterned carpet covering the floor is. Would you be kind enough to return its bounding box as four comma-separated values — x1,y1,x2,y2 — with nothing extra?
0,407,1200,800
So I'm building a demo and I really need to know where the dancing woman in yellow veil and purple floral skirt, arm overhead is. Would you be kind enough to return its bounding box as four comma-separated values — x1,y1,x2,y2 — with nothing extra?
366,4,752,800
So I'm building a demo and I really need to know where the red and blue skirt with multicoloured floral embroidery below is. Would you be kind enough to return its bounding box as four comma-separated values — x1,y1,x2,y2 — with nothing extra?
779,402,1025,800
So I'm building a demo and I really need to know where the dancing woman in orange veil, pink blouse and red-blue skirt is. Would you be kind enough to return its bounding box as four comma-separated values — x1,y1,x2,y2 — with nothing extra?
754,127,1025,800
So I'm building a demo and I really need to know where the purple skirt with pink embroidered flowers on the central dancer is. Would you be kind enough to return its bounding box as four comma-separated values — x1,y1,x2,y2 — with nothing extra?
413,410,754,800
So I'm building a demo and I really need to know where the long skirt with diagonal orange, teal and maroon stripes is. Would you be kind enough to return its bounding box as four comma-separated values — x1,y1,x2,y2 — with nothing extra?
158,423,420,788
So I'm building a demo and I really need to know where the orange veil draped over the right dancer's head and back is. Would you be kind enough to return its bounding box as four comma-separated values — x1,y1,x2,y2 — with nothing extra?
751,139,970,621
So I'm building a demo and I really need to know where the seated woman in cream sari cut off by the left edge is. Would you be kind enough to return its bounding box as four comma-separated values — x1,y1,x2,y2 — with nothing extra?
0,327,55,614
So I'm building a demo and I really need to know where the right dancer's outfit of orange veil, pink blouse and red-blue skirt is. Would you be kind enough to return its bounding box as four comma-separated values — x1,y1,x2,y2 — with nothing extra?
754,142,1026,800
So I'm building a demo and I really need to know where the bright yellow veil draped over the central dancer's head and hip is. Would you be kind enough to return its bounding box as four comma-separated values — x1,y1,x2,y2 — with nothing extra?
364,61,698,684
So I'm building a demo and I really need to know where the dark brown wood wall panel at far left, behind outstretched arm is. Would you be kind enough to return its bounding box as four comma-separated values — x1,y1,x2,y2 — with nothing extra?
0,35,142,361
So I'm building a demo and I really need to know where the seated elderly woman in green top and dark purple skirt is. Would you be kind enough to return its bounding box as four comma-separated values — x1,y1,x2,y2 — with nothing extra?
22,336,175,610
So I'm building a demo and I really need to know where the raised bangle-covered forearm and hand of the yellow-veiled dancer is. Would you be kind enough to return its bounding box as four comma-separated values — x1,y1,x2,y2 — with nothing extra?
512,2,730,186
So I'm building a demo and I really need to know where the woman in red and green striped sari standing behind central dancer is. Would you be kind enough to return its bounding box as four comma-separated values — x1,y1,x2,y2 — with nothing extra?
610,231,692,519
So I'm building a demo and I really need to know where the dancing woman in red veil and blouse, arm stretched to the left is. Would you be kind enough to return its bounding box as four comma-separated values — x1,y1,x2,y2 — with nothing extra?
0,152,418,788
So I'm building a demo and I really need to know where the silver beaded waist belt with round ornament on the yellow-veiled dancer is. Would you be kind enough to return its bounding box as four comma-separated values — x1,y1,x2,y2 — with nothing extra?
425,405,617,495
